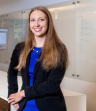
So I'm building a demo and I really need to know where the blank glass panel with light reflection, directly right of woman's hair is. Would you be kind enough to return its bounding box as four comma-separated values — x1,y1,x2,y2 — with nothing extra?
47,1,76,78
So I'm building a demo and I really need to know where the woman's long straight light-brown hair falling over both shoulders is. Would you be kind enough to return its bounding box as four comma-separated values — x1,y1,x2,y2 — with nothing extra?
16,6,67,71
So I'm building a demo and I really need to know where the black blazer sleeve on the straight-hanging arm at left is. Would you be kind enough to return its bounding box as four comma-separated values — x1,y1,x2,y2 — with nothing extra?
7,45,18,97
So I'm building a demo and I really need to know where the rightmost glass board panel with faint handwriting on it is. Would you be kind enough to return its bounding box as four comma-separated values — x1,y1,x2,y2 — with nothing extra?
76,0,96,83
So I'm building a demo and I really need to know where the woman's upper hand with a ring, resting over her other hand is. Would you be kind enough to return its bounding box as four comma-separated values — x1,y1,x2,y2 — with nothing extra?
8,90,25,105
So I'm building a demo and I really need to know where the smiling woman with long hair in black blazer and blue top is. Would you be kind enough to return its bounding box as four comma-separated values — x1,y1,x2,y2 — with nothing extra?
8,6,67,111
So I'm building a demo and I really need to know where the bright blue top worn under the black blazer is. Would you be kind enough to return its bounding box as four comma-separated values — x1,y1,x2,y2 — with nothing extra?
23,47,42,111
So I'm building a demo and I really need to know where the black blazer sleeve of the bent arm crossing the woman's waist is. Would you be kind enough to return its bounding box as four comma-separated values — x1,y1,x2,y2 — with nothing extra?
24,67,65,100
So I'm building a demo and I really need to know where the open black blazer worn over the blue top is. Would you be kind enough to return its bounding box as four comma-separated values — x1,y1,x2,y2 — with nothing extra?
8,43,66,111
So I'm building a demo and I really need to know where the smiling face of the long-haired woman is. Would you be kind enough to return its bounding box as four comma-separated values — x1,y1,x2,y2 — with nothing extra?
30,10,48,37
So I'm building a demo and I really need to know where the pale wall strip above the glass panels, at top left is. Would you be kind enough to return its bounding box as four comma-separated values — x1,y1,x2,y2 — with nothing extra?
0,0,71,15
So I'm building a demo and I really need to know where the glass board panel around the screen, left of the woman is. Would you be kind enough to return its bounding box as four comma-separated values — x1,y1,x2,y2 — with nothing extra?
0,12,23,64
